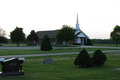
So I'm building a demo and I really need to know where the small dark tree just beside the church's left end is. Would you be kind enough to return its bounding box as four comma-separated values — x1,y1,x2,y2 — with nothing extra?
27,30,39,44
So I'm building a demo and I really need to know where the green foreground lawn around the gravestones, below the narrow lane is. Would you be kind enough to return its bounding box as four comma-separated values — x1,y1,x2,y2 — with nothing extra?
0,53,120,80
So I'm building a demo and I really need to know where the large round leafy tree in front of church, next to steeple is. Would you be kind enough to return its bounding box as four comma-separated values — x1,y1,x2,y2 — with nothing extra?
55,25,76,45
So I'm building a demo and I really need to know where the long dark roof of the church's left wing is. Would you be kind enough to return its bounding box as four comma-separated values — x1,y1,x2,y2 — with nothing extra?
36,30,58,38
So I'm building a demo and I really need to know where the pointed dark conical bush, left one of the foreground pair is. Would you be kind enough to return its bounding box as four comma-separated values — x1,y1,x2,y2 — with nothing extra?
74,49,92,67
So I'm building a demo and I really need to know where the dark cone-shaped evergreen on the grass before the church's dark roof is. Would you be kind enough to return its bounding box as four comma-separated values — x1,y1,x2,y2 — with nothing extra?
40,34,52,51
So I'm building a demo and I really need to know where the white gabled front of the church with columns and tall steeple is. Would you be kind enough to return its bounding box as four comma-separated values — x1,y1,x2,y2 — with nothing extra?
75,14,89,45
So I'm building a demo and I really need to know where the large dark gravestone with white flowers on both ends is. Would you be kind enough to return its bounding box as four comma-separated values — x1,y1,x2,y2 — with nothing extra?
0,58,25,77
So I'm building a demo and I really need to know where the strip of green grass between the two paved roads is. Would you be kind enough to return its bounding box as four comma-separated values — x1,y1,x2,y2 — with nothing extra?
0,48,118,56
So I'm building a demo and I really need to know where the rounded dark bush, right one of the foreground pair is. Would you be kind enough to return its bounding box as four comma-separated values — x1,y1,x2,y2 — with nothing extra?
93,50,107,66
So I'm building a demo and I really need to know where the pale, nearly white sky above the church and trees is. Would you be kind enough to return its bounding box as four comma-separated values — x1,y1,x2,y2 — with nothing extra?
0,0,120,39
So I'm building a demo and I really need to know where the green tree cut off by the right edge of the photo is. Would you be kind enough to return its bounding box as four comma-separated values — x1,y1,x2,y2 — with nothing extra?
110,25,120,46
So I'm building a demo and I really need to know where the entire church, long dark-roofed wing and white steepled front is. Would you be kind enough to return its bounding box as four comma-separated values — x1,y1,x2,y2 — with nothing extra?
36,14,89,45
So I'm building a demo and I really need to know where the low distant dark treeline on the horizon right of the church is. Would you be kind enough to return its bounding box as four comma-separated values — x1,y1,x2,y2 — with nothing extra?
91,39,120,44
